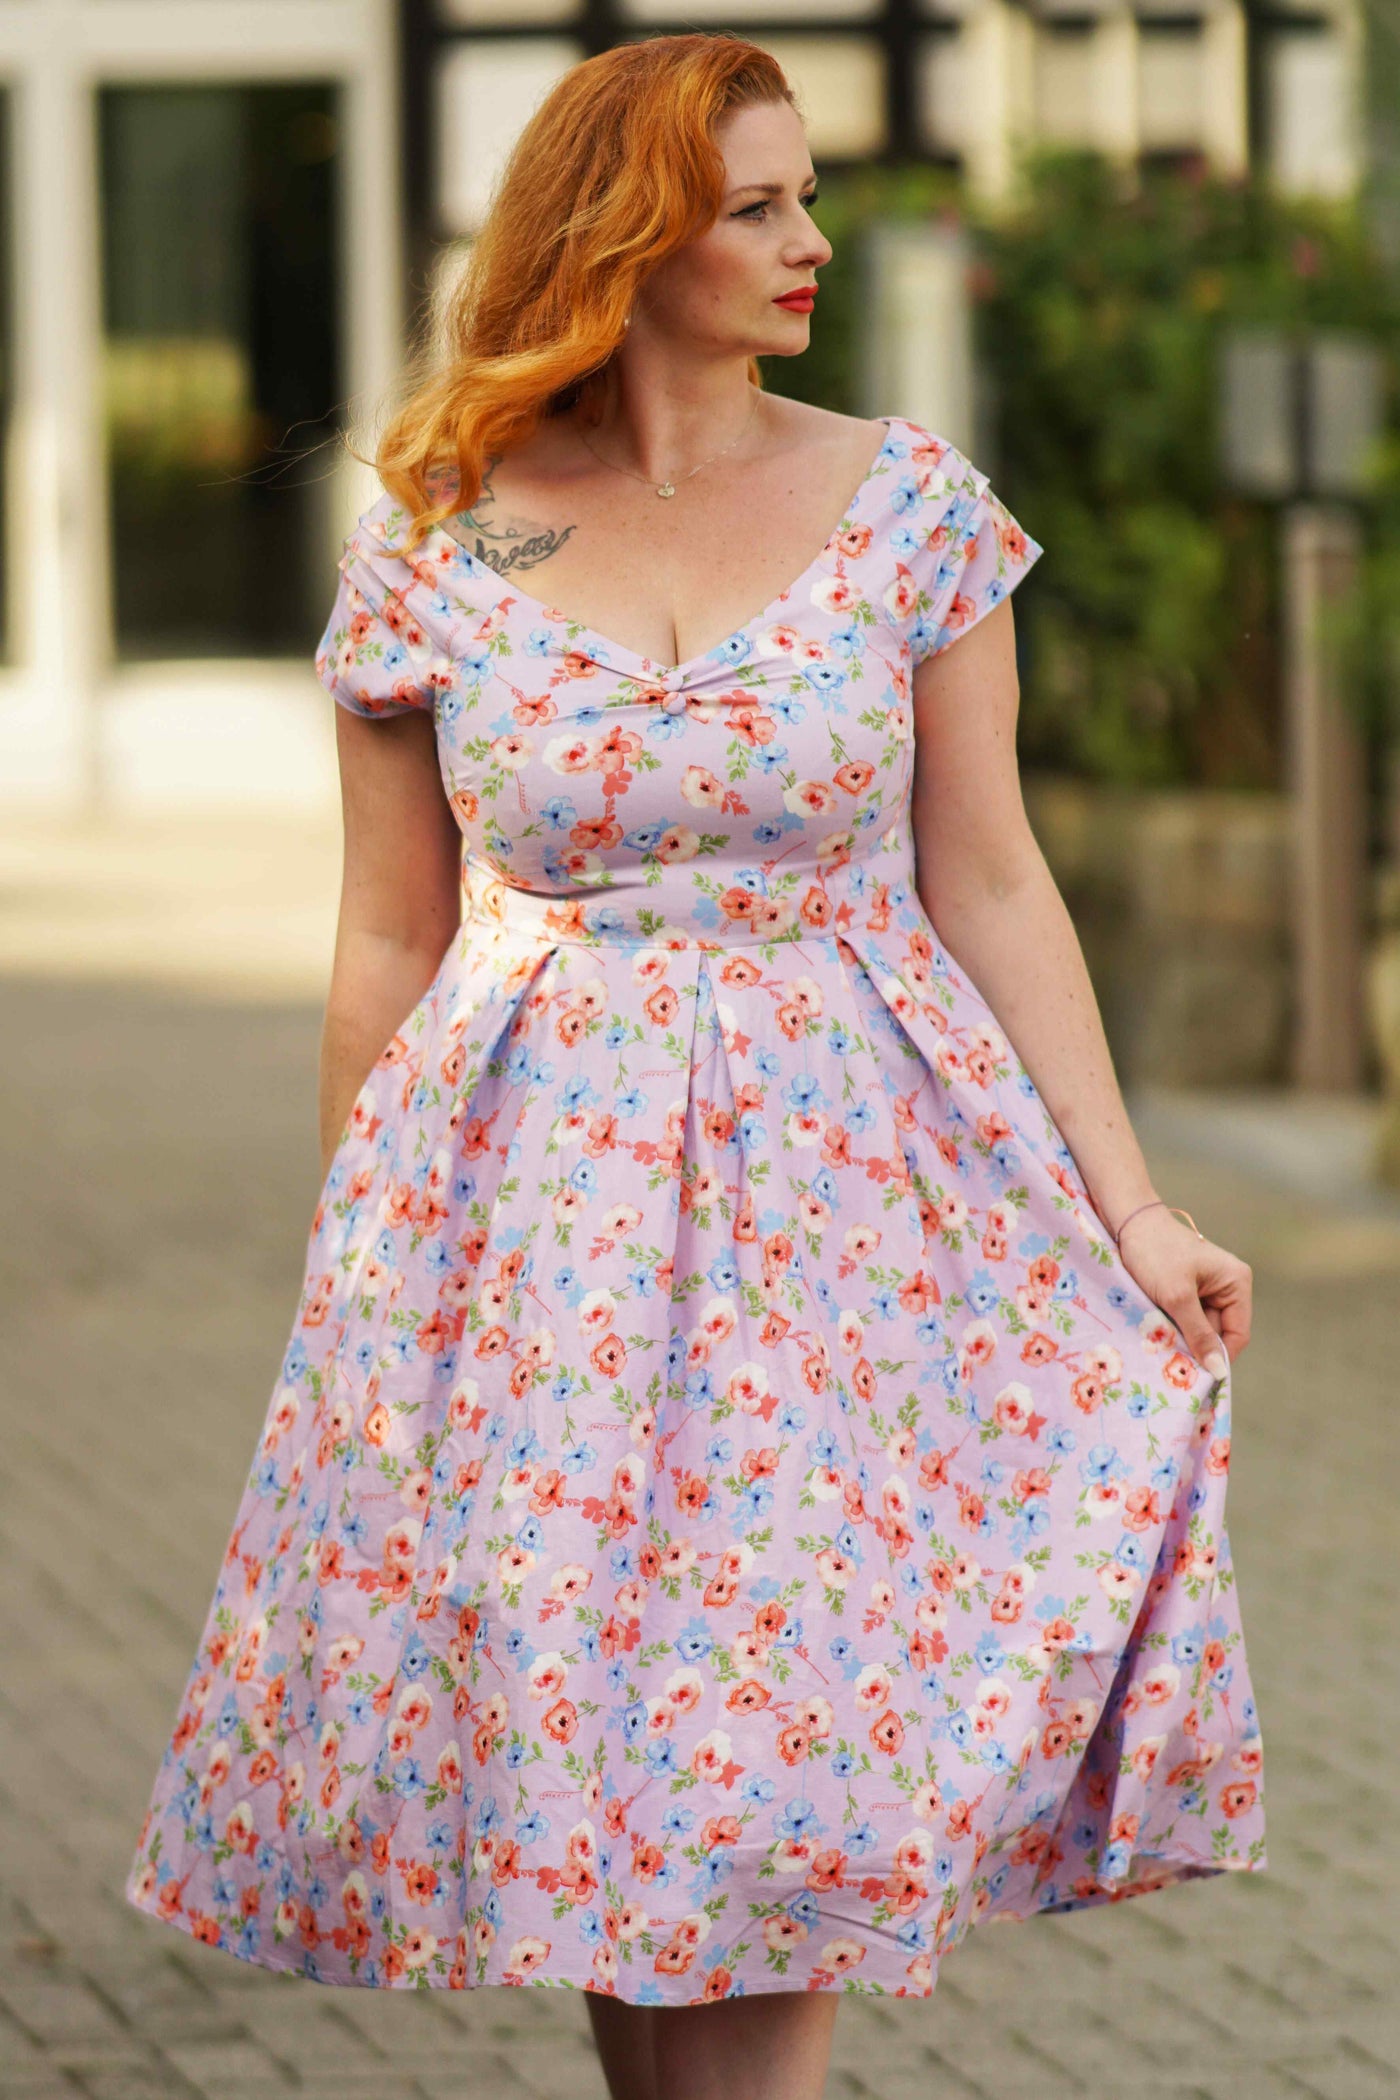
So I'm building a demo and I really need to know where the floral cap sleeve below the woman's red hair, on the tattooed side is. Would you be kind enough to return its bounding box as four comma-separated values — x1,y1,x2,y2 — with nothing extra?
315,506,434,718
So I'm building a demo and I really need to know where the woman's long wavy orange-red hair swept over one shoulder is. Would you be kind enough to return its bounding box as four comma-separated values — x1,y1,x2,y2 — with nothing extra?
374,32,798,552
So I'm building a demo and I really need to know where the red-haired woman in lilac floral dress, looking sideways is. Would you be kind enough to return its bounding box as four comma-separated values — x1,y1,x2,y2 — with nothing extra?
128,36,1266,2100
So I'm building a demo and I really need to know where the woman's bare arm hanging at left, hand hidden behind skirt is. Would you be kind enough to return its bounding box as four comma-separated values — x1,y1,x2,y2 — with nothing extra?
319,708,462,1176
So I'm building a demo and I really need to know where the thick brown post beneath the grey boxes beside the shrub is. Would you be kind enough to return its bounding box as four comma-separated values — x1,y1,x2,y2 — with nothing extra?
1282,502,1366,1092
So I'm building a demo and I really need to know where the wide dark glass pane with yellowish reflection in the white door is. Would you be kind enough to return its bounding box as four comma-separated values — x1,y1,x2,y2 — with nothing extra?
99,84,342,657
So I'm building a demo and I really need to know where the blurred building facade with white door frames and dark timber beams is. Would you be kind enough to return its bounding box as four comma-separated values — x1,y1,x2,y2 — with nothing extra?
0,0,1366,811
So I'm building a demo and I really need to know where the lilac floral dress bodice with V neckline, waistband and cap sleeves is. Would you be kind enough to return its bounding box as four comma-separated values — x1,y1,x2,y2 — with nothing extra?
321,418,1041,945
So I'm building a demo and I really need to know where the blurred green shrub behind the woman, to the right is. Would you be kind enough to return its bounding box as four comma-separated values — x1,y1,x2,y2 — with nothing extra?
764,151,1400,788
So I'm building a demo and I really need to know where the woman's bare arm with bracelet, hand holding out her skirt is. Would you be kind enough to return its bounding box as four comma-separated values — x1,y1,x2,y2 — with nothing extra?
913,599,1251,1371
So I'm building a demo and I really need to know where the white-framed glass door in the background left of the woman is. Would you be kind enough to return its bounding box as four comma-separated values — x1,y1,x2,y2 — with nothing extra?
0,0,403,809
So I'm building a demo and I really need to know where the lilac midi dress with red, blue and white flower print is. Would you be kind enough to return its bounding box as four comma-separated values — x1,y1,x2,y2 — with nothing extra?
126,416,1266,2006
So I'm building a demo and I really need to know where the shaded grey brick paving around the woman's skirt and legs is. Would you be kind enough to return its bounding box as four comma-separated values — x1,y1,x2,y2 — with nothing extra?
0,977,1400,2100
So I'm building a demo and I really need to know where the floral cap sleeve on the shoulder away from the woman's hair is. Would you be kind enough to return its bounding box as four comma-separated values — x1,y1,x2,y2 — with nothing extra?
892,431,1045,666
